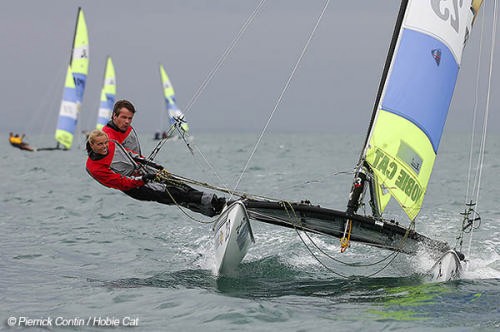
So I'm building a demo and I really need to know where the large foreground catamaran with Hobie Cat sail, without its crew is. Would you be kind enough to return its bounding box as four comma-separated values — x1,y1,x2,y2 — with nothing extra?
213,0,482,281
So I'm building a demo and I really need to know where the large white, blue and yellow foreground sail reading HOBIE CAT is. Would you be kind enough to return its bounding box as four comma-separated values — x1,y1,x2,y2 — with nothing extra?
364,0,482,220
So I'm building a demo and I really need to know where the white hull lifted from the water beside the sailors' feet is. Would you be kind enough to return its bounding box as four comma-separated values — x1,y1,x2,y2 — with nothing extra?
214,201,255,274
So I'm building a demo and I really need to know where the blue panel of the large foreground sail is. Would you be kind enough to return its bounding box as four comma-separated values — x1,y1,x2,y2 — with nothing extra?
382,29,459,153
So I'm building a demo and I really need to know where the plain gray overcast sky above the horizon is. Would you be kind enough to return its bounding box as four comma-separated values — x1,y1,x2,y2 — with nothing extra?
0,0,500,134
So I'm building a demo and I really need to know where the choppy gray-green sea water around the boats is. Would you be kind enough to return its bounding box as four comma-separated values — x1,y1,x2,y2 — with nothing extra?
0,133,500,331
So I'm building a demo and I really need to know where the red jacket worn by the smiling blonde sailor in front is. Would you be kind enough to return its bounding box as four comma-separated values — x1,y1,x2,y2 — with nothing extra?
86,141,144,191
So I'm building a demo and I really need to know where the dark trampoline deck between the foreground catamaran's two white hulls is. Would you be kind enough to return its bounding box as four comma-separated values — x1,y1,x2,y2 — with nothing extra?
242,200,450,254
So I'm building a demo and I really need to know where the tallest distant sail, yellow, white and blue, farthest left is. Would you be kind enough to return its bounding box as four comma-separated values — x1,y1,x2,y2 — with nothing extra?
55,8,89,149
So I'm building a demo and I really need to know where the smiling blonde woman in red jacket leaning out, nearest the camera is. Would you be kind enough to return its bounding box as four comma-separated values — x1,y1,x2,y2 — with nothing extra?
86,129,226,217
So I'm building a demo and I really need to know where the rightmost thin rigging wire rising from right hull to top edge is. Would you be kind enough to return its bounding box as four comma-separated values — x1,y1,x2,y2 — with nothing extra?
467,0,498,256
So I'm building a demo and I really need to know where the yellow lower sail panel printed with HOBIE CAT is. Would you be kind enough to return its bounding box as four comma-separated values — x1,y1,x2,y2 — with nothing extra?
366,110,436,220
